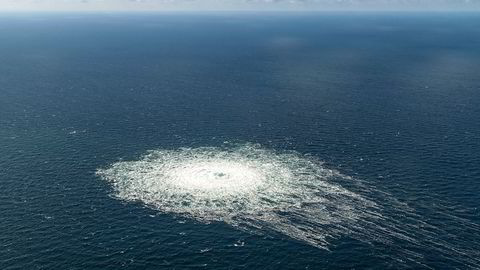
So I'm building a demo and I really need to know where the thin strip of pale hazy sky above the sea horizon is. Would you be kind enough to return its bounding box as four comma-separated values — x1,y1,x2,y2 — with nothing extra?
0,0,480,11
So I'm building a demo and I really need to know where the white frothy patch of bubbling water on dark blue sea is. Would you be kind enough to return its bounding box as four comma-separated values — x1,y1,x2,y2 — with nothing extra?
97,144,379,248
